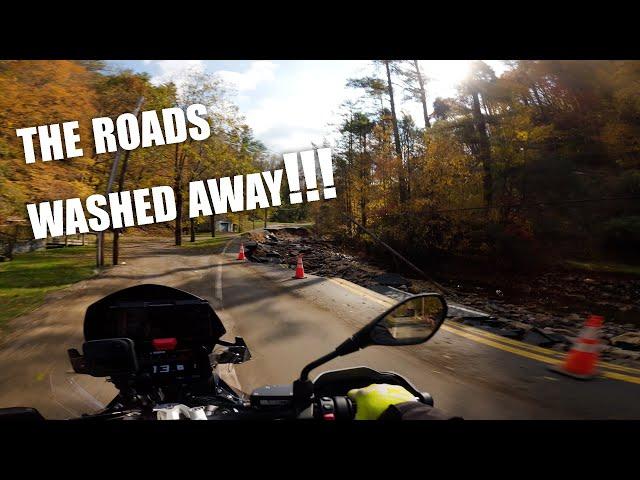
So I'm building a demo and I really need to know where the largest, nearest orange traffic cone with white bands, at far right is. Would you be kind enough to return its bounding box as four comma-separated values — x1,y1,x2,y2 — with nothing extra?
551,315,604,380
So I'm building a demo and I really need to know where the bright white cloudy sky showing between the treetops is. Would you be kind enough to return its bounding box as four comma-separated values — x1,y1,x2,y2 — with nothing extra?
108,60,506,154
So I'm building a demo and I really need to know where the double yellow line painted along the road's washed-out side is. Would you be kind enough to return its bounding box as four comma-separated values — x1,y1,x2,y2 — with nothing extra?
329,278,640,384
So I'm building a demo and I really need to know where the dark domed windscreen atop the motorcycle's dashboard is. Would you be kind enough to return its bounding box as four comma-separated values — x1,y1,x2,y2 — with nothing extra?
84,284,226,347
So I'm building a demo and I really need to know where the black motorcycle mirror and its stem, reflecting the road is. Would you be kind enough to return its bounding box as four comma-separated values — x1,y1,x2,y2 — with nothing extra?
299,293,447,382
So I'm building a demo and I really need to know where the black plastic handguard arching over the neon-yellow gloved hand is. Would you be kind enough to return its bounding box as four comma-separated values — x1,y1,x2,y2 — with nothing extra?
313,366,433,406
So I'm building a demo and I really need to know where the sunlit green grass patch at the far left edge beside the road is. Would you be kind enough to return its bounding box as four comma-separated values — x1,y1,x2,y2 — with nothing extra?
0,245,95,328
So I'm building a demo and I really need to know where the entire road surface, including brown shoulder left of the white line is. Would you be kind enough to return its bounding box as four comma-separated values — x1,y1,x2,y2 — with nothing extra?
0,234,640,419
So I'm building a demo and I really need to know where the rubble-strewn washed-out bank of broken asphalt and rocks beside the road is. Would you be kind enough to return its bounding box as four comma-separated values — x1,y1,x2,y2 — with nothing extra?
246,228,640,366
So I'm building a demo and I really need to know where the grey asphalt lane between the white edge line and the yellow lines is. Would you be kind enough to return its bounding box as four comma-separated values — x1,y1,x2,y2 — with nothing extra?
222,238,640,419
